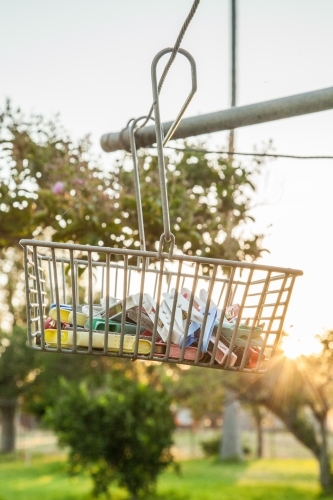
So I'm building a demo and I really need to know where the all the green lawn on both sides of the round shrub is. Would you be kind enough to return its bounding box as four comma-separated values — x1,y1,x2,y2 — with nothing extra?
0,455,328,500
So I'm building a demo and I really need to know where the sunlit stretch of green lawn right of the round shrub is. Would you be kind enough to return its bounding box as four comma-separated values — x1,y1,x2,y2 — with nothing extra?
159,459,320,500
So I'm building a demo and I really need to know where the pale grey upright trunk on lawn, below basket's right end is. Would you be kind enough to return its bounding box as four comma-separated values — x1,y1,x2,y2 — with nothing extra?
220,389,243,461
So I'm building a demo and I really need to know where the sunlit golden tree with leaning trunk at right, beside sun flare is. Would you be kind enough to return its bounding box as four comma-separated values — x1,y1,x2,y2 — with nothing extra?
218,346,333,494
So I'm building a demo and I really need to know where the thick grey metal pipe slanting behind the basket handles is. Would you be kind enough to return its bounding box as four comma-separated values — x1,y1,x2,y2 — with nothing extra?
101,87,333,153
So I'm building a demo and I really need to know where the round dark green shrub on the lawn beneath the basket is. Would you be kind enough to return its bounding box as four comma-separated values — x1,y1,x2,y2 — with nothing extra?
47,373,174,496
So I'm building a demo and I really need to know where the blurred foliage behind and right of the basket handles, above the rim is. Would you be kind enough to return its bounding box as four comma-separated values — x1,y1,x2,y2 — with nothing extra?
114,148,264,261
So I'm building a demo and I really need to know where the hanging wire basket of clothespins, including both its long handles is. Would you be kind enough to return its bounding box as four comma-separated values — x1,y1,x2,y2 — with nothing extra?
20,49,302,373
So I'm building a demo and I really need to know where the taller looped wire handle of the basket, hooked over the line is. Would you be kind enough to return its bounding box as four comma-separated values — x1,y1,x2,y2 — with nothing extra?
151,48,197,247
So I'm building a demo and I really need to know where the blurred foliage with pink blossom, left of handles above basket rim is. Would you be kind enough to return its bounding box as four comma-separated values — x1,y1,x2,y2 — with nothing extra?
0,102,118,248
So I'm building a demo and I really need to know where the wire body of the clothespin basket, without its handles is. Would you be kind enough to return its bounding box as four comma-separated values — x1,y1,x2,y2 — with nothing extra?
21,240,299,373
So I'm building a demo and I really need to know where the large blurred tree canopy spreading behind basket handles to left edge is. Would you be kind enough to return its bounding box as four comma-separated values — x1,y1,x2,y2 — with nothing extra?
0,98,263,454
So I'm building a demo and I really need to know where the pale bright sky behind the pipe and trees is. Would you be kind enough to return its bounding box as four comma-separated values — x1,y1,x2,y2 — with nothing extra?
0,0,333,353
